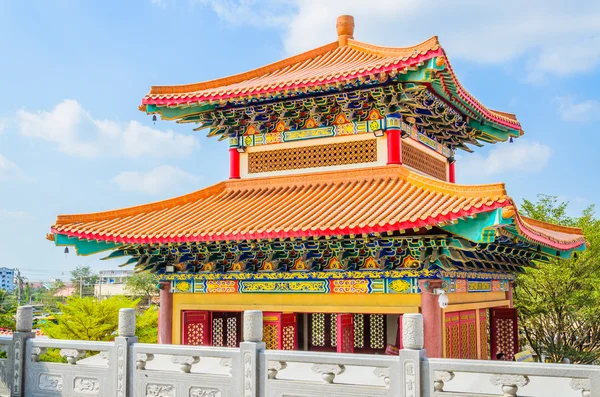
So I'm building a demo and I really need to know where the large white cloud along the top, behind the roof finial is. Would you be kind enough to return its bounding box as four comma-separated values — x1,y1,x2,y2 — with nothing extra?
198,0,600,80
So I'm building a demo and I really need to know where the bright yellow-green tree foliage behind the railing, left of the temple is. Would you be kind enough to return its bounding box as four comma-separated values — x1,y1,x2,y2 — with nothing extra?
42,296,158,342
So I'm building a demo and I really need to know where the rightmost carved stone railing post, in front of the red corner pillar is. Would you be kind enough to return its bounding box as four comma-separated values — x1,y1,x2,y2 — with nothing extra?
400,313,425,397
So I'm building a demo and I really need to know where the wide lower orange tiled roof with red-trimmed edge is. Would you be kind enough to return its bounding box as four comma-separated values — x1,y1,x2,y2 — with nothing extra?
51,165,585,256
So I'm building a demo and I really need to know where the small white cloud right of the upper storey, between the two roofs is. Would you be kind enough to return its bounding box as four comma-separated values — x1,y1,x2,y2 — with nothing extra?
456,140,552,183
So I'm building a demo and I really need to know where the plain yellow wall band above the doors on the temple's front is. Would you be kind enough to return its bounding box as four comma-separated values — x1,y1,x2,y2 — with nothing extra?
173,293,421,344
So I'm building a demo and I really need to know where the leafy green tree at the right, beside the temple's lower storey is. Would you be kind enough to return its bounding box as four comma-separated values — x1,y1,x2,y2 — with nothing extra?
515,195,600,364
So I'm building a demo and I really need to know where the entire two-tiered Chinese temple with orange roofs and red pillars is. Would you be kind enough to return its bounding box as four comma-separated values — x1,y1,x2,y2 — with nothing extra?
48,16,586,359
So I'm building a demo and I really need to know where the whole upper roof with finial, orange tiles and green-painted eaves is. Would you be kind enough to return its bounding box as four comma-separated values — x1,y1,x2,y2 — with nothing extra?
140,16,522,149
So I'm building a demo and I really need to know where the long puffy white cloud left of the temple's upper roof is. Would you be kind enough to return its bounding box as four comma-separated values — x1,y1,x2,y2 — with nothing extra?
17,99,199,158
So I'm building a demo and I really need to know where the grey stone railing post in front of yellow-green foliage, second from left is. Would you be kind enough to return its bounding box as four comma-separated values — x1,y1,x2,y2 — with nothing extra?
113,308,138,397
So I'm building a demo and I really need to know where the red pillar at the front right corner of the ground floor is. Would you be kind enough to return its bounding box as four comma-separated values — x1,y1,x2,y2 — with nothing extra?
419,280,444,358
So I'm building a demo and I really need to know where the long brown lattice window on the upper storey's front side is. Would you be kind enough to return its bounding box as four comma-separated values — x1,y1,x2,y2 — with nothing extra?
248,139,377,174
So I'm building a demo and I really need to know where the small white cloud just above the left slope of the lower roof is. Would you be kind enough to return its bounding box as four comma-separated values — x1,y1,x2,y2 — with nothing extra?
112,165,200,195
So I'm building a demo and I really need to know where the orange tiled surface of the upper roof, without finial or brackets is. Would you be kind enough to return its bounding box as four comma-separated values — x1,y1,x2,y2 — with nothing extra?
141,36,521,130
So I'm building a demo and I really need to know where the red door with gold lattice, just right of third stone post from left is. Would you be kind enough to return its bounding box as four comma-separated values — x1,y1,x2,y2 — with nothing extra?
263,312,298,350
